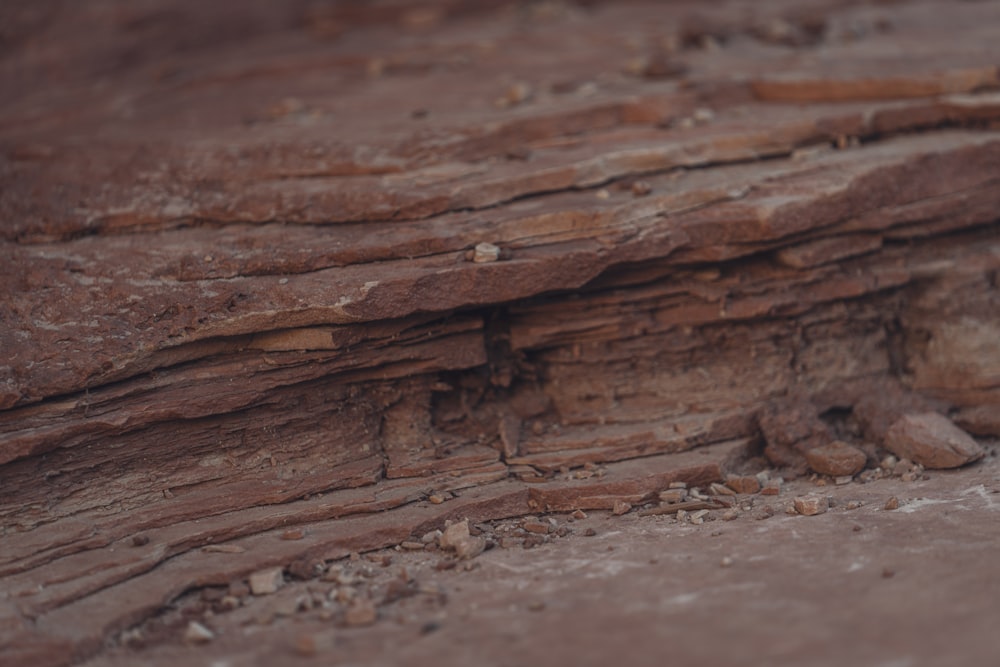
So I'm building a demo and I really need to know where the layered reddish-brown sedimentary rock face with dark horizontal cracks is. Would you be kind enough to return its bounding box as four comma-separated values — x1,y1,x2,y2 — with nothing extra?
0,0,1000,665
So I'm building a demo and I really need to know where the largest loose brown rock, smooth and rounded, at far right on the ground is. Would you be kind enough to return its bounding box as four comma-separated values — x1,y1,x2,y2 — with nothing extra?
885,412,985,468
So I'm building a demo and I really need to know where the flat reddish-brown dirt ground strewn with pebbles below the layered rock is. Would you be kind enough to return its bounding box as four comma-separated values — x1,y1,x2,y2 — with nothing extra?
86,443,1000,667
